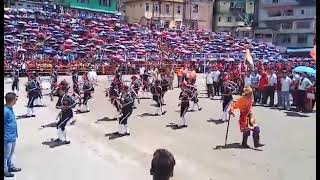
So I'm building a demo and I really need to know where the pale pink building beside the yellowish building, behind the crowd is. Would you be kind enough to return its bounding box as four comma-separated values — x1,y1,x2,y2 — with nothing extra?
184,0,214,31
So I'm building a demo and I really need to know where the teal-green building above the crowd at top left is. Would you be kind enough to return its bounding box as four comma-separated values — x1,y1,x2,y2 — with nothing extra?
59,0,117,14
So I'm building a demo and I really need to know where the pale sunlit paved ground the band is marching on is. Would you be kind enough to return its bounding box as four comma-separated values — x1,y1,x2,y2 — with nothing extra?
5,76,316,180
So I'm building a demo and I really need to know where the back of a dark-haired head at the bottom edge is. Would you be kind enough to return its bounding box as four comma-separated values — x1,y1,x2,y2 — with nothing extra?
150,149,176,180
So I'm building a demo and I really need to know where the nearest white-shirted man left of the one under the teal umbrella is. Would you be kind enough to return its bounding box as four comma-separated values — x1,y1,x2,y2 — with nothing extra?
281,71,292,110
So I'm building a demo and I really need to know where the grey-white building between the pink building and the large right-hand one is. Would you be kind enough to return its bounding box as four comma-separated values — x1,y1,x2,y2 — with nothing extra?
214,0,254,37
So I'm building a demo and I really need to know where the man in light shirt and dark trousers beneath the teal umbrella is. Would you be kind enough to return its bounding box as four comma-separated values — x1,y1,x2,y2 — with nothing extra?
297,73,312,112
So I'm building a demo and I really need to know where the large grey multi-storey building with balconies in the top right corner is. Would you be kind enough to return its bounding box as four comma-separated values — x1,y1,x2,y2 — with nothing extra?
254,0,316,53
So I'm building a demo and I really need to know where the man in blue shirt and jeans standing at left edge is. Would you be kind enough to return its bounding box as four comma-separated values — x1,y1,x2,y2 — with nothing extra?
4,92,21,177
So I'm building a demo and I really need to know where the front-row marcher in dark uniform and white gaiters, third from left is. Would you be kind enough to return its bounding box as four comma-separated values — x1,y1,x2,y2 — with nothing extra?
177,83,192,128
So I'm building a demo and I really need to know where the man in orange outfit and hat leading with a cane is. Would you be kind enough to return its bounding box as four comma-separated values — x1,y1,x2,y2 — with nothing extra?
229,87,264,148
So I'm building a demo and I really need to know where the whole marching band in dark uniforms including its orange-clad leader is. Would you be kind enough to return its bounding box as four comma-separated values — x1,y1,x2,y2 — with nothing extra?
12,64,263,148
